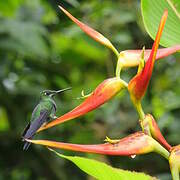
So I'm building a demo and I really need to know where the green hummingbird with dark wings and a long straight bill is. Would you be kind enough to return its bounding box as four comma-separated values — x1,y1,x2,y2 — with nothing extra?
22,87,71,150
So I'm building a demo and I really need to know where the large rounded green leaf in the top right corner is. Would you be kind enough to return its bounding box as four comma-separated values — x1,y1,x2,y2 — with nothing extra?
141,0,180,47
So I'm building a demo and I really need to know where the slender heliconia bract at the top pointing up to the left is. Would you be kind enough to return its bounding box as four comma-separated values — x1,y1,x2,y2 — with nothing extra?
59,6,119,56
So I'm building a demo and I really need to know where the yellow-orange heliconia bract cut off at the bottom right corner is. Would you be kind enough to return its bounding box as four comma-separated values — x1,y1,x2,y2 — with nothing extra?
169,145,180,180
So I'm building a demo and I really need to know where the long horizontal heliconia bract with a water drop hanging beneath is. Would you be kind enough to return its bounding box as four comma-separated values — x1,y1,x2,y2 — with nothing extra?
26,132,169,158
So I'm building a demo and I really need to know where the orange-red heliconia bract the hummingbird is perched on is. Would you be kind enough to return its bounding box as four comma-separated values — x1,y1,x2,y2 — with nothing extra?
39,77,127,131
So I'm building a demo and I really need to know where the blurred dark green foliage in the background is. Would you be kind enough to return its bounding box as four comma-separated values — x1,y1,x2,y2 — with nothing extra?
0,0,180,180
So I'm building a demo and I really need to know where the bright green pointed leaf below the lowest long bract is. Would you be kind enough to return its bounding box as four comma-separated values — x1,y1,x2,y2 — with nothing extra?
48,148,155,180
